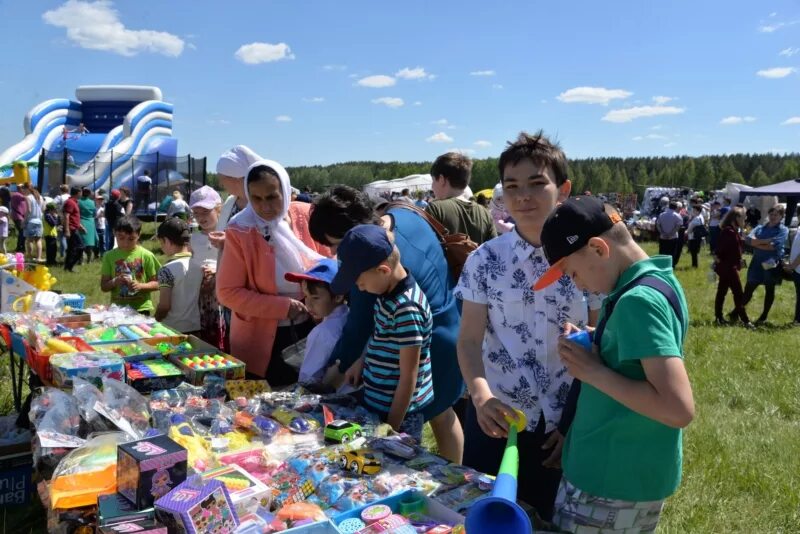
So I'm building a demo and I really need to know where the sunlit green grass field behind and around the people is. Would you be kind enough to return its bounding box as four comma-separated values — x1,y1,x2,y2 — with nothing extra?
0,231,800,533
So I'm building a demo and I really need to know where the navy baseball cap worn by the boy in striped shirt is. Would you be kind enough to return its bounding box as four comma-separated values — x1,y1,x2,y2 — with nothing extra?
331,224,394,295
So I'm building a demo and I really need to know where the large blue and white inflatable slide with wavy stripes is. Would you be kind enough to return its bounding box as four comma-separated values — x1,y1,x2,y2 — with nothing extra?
0,85,178,196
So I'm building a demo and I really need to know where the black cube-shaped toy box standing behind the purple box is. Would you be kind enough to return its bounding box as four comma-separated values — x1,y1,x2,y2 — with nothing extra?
117,435,187,510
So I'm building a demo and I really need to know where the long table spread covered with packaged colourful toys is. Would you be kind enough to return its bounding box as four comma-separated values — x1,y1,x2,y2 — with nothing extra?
0,306,494,534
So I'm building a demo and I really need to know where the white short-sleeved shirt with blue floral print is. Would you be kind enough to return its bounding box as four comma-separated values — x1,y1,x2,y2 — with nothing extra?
455,229,602,432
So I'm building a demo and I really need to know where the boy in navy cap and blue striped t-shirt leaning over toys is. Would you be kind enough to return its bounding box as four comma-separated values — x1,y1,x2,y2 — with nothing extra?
331,224,433,441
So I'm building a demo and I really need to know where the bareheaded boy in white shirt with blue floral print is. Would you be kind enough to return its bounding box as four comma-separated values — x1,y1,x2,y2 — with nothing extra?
455,132,600,520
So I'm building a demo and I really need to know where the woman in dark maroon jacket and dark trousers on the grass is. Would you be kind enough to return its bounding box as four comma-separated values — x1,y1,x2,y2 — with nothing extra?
714,207,754,328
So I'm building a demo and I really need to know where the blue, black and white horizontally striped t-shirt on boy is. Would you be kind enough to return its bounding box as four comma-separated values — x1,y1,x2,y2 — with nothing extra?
364,274,433,413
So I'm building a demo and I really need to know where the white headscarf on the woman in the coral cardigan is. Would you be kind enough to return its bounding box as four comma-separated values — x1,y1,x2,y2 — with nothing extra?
230,159,322,294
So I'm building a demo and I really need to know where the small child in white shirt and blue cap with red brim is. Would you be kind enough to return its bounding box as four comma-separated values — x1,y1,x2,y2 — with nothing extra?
285,258,350,387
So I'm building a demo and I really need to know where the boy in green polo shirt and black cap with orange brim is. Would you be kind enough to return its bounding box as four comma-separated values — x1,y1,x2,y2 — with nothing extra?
535,197,694,534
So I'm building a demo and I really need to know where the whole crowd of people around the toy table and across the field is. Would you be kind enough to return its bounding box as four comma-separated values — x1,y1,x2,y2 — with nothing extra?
6,132,800,532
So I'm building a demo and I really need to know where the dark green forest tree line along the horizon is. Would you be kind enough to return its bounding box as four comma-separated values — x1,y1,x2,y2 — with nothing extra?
208,154,800,194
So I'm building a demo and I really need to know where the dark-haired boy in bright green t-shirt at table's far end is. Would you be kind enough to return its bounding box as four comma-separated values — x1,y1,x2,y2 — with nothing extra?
100,216,161,315
